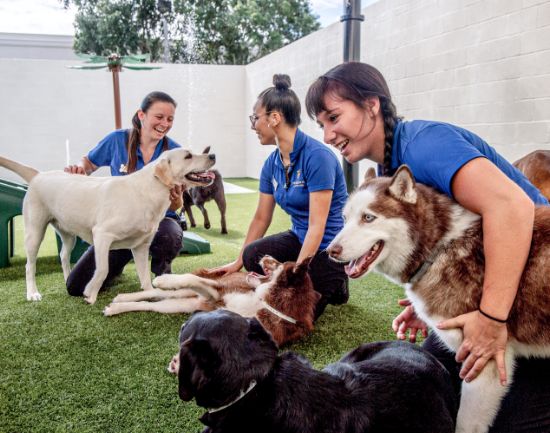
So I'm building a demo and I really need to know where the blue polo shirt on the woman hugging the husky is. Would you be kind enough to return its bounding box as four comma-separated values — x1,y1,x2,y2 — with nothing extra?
384,120,549,205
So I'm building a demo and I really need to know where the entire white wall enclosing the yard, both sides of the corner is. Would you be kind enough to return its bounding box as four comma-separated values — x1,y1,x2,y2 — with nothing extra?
0,0,550,182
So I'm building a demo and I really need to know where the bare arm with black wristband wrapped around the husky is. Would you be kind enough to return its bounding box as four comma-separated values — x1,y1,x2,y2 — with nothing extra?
438,158,535,384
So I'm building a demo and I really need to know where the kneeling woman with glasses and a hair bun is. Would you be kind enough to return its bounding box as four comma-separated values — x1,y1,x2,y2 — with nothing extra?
212,75,349,317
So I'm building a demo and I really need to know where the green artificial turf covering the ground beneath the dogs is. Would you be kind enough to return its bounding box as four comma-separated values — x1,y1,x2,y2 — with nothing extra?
0,179,402,433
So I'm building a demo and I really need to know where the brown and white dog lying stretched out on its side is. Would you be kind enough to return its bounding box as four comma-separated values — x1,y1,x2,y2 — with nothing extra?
104,256,320,346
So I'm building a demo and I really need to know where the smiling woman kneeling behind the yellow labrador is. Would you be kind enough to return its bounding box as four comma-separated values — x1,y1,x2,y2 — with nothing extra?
65,92,183,296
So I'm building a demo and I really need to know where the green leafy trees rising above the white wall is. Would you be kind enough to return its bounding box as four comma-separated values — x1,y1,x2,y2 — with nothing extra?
62,0,320,64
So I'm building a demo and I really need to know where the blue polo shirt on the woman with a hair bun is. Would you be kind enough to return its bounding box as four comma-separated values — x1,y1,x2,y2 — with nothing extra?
260,129,348,249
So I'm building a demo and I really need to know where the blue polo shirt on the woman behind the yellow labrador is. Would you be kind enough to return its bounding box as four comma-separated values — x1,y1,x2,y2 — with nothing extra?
88,129,181,219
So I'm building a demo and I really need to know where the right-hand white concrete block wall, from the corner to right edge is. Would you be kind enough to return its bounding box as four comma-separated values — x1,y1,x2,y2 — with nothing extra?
246,0,550,176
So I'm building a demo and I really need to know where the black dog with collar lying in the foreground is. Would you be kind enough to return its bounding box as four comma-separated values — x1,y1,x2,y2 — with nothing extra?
178,310,457,433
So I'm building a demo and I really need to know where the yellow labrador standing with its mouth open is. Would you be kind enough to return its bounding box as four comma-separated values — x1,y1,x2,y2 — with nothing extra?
0,149,216,304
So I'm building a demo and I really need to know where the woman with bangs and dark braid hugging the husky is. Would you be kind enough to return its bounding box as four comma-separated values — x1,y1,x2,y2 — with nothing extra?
306,62,550,433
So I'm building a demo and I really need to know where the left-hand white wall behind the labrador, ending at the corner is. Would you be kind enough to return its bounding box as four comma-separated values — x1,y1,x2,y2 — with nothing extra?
0,59,246,179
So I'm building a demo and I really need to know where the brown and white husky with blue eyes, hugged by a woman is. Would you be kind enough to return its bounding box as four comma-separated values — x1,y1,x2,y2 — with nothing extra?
328,166,550,433
